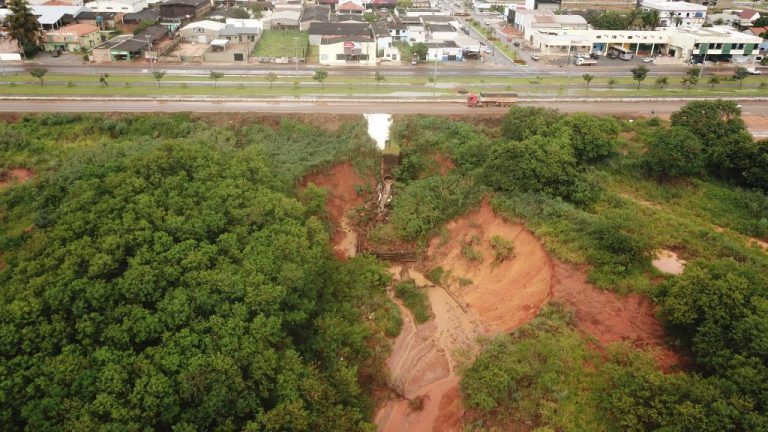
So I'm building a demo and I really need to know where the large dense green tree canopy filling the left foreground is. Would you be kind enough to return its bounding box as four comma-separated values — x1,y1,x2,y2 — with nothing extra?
0,114,389,431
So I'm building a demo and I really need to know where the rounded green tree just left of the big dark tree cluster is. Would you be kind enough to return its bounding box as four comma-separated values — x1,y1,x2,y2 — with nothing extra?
643,127,704,179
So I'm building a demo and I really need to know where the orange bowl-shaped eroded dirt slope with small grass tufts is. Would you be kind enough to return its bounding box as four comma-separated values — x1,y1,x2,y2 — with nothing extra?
429,202,552,333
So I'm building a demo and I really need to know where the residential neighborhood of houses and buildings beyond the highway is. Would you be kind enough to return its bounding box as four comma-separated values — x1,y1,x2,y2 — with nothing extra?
0,0,768,69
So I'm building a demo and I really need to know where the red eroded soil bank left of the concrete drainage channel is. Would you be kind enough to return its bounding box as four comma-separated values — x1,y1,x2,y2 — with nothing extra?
300,162,374,259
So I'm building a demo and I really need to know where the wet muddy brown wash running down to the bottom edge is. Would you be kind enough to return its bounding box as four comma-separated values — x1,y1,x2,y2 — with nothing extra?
375,266,482,432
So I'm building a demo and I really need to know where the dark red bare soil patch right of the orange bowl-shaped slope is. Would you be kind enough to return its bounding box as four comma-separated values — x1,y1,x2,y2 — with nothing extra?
552,261,686,372
